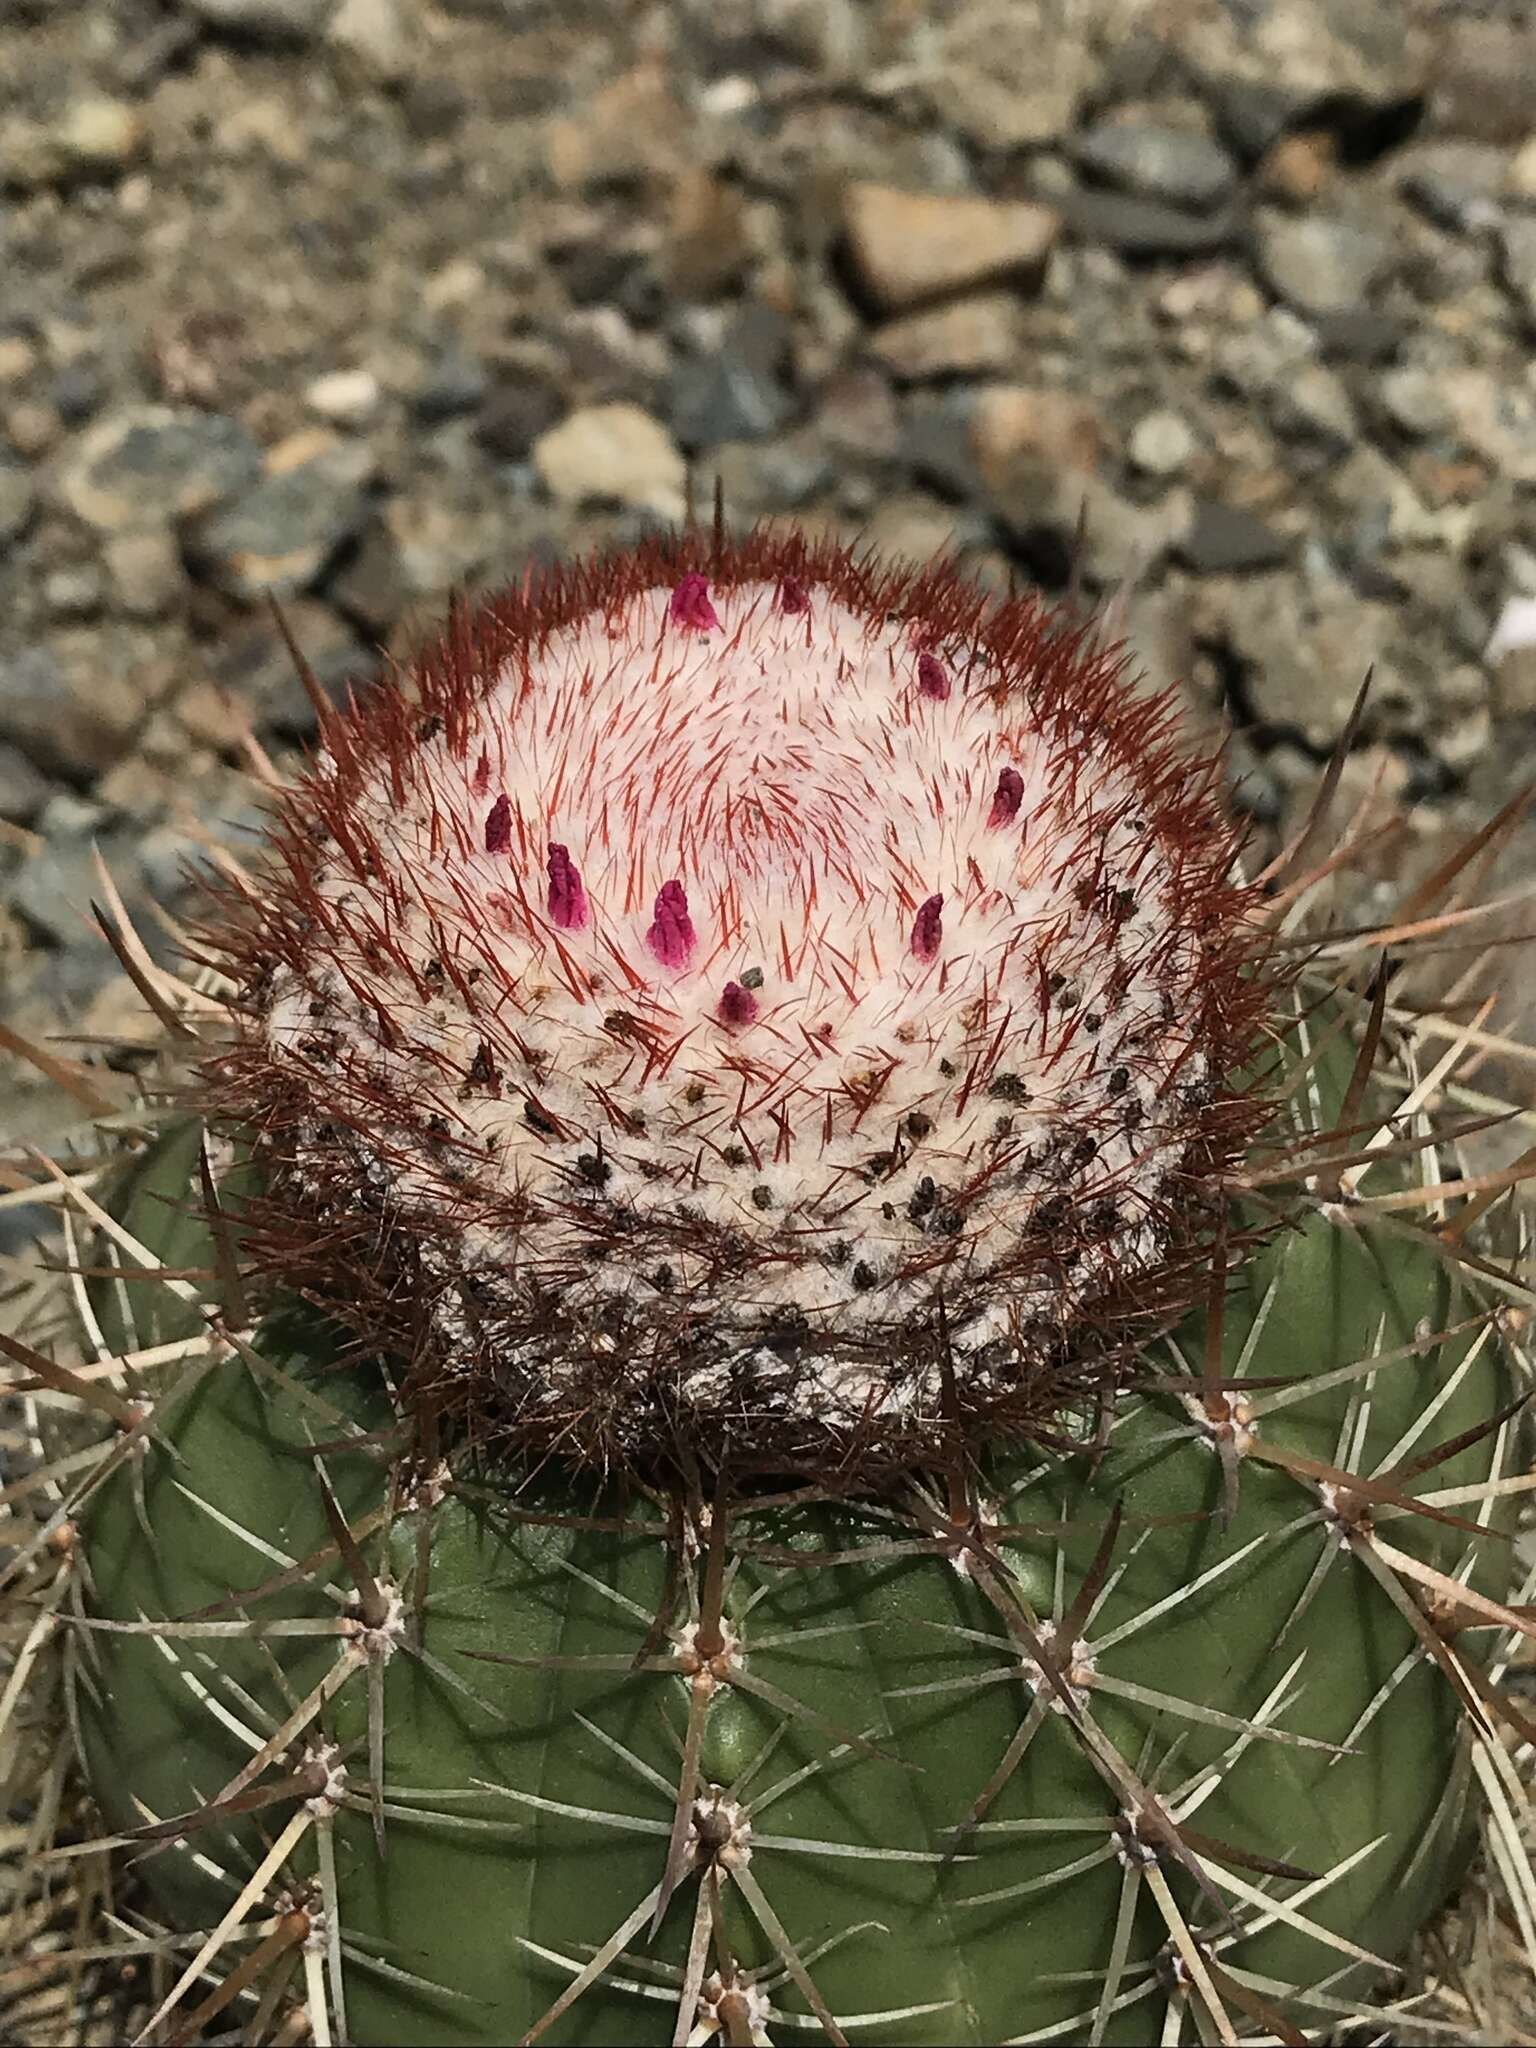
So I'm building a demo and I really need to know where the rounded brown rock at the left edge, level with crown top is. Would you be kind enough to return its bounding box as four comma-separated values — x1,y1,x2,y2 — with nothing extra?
0,635,145,782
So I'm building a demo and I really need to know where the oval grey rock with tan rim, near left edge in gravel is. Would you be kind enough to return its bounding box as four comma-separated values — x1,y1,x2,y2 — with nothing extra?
59,406,262,530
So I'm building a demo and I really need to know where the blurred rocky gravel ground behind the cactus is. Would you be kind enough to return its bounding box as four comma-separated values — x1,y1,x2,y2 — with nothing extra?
0,0,1536,1171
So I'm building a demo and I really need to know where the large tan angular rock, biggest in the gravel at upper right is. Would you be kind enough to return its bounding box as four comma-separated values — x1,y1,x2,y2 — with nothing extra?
842,184,1059,313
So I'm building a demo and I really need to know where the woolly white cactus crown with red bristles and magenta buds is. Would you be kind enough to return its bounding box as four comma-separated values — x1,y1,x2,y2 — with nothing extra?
207,537,1270,1477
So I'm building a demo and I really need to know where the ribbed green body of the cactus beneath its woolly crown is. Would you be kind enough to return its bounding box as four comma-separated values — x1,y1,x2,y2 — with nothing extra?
82,1048,1505,2044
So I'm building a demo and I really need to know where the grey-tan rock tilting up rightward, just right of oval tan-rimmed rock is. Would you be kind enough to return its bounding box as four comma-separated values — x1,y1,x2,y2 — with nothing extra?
188,444,373,604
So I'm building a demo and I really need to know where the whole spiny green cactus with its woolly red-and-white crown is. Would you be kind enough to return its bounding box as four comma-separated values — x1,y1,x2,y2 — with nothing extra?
10,535,1536,2044
